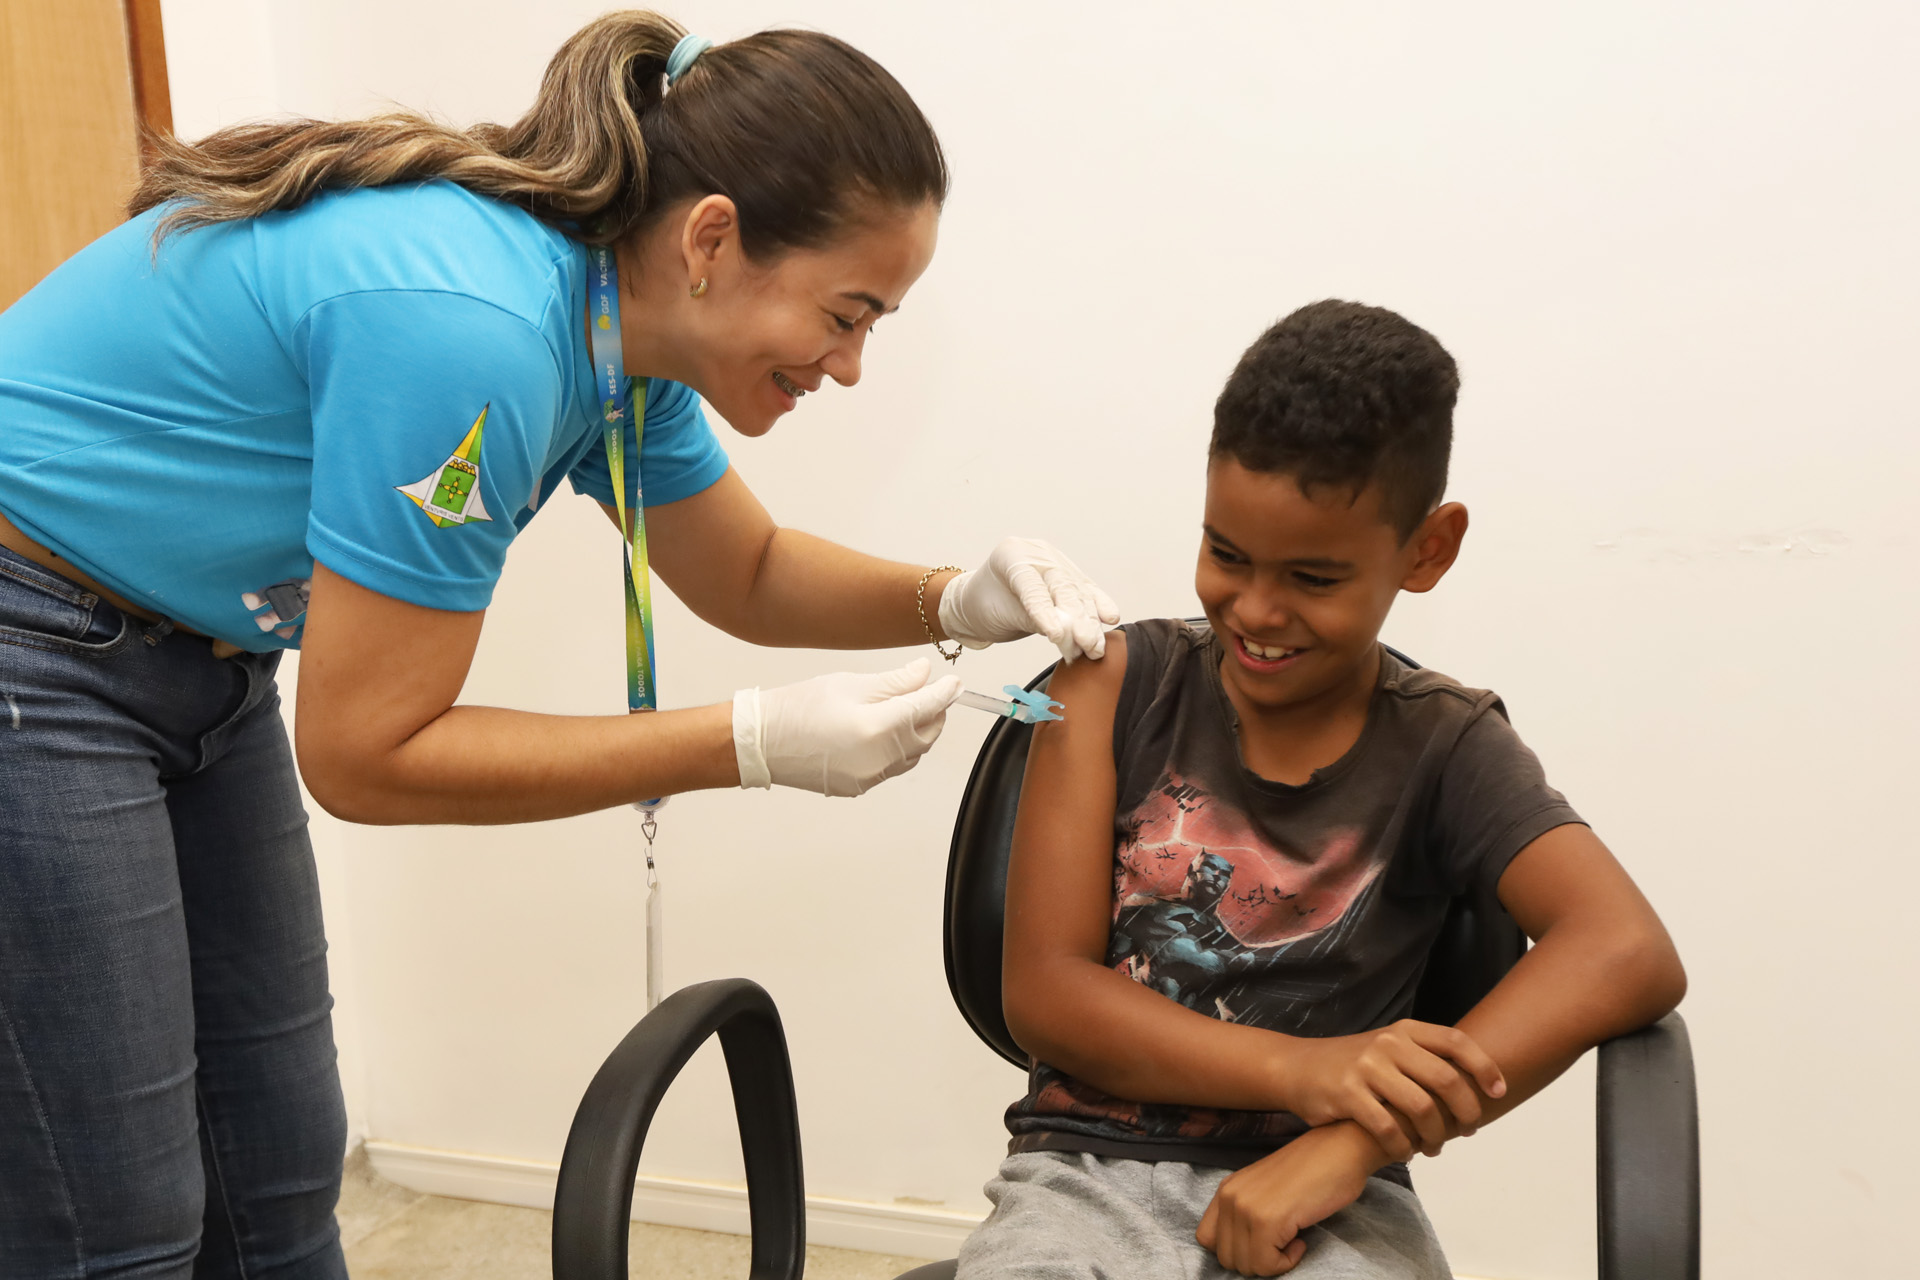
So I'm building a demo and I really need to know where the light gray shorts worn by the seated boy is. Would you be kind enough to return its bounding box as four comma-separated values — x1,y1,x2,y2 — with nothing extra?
958,1151,1452,1280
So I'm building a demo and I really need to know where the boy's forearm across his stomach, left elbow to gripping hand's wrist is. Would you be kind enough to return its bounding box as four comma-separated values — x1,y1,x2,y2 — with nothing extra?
1004,960,1294,1111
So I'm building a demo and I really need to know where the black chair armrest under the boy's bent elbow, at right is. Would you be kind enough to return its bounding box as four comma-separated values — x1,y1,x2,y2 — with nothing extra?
1597,1013,1699,1280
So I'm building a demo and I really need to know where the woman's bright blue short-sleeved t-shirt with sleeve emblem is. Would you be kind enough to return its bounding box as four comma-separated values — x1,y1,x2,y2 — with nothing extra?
0,182,728,651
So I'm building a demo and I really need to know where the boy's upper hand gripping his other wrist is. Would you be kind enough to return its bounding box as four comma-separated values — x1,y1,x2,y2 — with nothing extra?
1281,1019,1507,1159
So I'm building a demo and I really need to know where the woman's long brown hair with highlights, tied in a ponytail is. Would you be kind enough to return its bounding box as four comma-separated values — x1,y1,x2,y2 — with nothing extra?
129,10,947,257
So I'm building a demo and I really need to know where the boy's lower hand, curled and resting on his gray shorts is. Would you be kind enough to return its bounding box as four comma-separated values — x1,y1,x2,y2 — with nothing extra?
1194,1125,1386,1276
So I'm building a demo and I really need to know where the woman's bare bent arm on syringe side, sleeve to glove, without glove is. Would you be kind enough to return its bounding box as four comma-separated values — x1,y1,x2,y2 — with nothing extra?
294,564,739,823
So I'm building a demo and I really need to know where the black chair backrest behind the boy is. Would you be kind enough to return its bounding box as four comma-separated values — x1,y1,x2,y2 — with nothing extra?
943,651,1526,1067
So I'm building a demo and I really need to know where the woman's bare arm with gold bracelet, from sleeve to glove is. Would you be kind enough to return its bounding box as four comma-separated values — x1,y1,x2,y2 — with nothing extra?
625,468,952,649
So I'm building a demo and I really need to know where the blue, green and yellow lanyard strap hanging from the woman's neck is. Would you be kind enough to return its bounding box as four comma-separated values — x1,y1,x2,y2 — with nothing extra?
588,244,657,712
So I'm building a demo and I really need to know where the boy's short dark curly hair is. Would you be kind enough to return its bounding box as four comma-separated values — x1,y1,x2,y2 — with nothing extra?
1208,299,1459,539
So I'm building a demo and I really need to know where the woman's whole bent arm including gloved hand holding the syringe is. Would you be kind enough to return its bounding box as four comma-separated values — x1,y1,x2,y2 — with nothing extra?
294,564,960,823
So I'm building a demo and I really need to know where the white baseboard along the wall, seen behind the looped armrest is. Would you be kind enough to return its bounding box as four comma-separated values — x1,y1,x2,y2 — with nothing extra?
367,1142,985,1257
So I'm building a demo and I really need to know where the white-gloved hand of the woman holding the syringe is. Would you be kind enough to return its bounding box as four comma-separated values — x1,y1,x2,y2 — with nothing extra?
733,658,960,796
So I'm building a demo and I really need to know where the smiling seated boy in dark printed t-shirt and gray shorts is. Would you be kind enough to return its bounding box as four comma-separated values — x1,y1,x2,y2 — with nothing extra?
960,301,1686,1280
